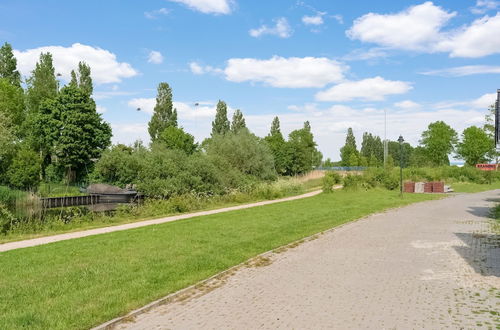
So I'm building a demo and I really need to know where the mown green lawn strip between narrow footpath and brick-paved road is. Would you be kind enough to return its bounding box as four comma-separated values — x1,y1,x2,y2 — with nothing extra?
0,190,442,329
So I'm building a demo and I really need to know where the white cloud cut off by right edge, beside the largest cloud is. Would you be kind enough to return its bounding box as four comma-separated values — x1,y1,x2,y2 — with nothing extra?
436,13,500,57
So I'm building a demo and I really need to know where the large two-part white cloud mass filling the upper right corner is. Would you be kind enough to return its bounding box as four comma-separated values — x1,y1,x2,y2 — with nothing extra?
346,2,500,58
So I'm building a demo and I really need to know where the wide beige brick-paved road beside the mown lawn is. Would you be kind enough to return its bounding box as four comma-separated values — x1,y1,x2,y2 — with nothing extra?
113,190,500,329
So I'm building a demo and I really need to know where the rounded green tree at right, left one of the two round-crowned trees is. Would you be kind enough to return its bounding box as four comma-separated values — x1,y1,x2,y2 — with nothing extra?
420,121,457,166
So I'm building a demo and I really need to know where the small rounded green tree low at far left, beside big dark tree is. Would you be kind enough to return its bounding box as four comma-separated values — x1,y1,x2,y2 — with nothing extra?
7,147,41,189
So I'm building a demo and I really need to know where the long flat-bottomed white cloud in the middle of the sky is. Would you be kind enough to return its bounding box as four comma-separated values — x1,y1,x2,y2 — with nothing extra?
224,56,347,88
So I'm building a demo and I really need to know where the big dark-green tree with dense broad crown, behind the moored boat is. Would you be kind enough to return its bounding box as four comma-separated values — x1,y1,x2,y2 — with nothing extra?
37,84,111,181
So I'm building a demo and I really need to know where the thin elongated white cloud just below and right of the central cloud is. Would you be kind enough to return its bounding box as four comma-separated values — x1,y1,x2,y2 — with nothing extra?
315,77,412,101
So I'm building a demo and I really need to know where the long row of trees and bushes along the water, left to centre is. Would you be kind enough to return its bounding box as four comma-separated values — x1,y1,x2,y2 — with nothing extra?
0,43,322,192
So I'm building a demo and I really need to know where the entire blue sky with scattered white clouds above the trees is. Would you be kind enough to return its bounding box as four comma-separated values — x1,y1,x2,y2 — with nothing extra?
0,0,500,159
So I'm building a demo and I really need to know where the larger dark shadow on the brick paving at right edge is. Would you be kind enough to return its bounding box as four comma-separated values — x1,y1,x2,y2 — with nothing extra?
453,233,500,277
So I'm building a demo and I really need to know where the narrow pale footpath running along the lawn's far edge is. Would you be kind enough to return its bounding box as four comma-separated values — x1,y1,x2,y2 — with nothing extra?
0,190,321,252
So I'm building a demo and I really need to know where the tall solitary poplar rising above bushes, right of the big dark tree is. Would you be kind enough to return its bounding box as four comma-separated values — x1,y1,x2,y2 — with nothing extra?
148,82,177,142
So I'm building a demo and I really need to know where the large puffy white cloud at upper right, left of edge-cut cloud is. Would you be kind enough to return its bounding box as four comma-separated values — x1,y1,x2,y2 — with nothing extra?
346,2,456,51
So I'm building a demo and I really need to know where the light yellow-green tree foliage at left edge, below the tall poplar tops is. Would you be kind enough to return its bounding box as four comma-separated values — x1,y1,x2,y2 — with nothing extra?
0,78,25,137
